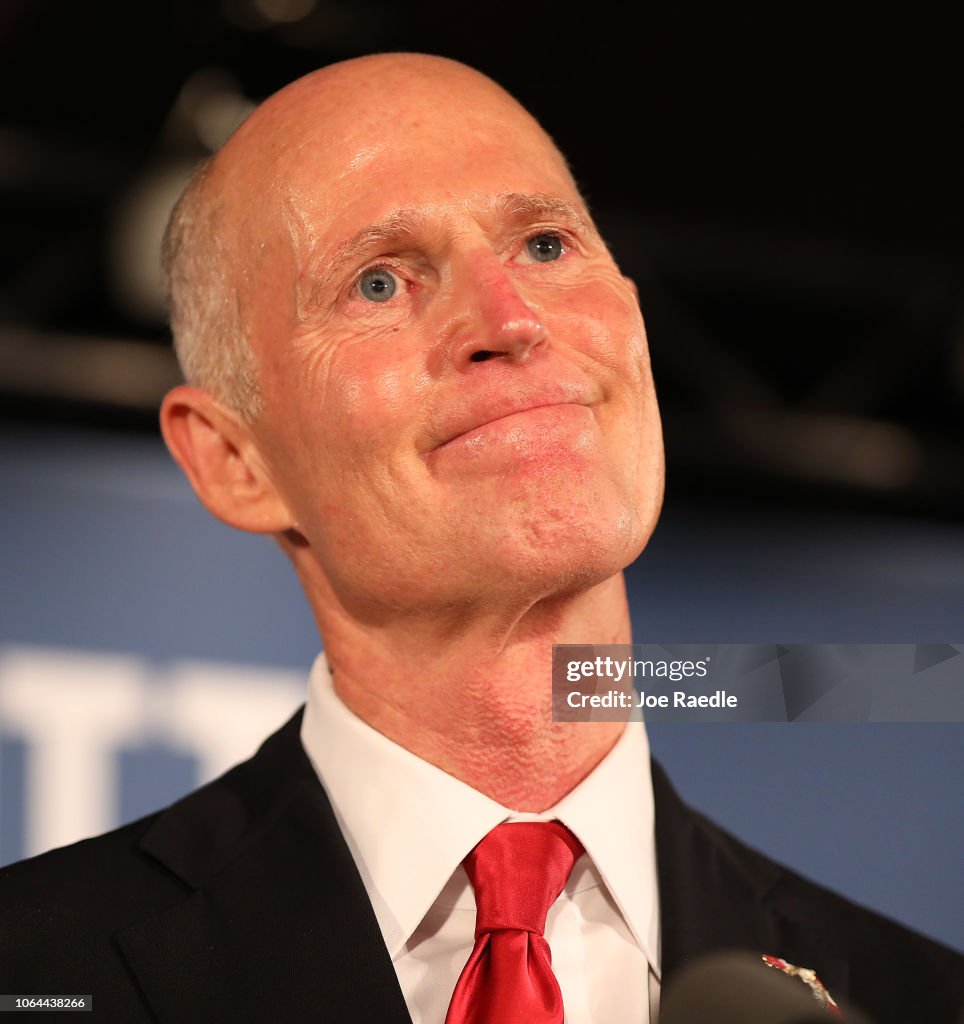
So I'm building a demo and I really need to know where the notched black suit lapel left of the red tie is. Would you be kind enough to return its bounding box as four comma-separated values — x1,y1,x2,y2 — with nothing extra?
115,714,410,1024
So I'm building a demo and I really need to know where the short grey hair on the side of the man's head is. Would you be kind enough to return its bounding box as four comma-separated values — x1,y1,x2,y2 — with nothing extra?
161,157,262,422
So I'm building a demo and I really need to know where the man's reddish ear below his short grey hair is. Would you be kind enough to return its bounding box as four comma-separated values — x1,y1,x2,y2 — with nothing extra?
161,384,294,534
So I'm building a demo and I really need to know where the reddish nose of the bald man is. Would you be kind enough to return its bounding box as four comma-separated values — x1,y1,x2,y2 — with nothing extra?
451,254,547,371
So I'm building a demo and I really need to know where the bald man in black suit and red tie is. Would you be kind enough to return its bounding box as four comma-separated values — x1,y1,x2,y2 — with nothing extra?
0,54,962,1024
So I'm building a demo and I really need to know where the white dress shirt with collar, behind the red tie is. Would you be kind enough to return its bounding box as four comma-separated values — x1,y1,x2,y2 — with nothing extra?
301,655,660,1024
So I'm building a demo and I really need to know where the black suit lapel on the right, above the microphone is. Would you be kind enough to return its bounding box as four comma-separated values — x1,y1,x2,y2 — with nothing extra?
653,762,848,998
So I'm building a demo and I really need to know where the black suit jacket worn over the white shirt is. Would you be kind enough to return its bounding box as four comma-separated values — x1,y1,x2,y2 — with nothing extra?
0,713,964,1024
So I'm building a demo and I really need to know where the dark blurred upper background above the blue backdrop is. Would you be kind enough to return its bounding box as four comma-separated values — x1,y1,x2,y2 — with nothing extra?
0,0,964,521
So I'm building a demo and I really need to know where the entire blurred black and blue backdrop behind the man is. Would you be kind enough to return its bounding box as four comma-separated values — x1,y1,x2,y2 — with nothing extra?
0,0,964,947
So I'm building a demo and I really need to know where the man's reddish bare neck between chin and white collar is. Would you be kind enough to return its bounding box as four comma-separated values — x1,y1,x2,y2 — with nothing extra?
309,573,630,812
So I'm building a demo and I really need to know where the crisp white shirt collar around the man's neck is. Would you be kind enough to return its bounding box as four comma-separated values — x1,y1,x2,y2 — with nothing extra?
301,655,659,972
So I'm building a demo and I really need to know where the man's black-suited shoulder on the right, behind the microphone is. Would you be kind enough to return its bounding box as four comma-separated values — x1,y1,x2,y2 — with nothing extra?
654,764,964,1021
